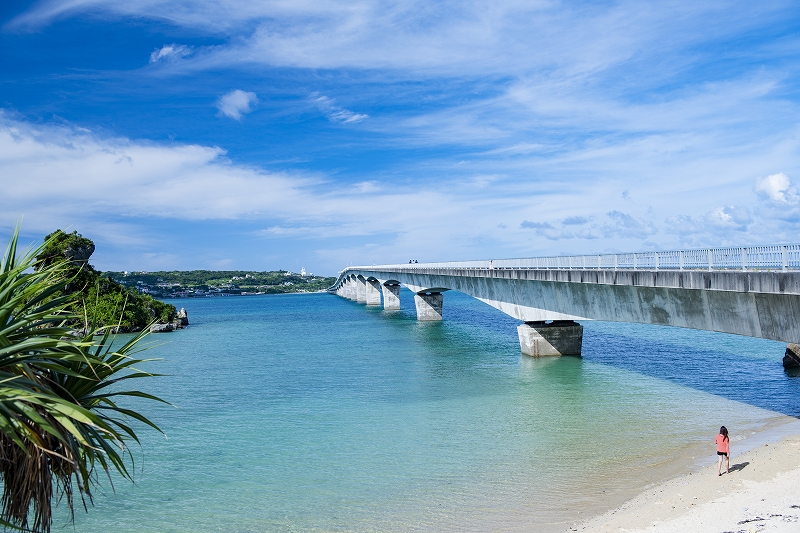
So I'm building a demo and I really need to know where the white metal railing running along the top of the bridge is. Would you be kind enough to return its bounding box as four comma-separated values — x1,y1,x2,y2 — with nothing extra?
340,244,800,272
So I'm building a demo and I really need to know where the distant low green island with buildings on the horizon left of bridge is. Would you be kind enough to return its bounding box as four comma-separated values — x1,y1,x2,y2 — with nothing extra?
102,269,336,298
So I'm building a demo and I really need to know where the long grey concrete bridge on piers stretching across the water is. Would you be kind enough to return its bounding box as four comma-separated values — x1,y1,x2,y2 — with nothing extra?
328,244,800,367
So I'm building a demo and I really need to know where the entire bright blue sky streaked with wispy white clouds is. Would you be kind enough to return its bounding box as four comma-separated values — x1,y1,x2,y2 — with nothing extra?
0,0,800,275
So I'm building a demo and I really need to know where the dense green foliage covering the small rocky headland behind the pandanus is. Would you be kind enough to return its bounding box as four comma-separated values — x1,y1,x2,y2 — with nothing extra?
36,230,176,331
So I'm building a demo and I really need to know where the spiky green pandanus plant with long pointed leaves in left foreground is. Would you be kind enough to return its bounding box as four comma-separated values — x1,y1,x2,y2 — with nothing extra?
0,228,163,533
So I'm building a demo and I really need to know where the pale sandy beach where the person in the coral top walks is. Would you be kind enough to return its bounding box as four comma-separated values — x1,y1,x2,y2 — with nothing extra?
565,417,800,533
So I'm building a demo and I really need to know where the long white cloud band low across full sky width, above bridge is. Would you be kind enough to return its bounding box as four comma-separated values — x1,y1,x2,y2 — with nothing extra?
0,110,800,272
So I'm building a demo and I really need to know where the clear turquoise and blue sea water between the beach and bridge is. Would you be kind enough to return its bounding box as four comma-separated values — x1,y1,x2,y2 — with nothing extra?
64,290,800,533
